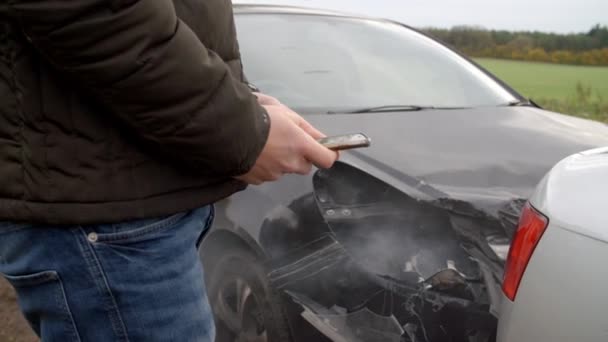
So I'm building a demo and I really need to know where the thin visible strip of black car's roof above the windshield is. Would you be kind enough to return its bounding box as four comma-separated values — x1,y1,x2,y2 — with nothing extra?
233,3,372,20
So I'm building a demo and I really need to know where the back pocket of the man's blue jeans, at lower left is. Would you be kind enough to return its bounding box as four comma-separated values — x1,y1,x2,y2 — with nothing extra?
5,271,80,342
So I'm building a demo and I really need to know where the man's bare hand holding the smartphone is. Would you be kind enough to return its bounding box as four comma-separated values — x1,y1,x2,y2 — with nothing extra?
237,105,338,184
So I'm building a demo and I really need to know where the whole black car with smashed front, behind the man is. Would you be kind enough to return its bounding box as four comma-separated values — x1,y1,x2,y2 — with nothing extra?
201,5,608,342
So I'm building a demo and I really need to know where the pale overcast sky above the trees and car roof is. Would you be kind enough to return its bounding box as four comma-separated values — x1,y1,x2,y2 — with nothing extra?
234,0,608,33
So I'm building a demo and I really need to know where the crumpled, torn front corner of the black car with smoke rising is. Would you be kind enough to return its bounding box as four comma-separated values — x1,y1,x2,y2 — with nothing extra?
269,166,524,342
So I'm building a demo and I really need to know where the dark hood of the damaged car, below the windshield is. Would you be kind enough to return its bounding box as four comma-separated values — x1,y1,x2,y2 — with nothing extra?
307,107,608,215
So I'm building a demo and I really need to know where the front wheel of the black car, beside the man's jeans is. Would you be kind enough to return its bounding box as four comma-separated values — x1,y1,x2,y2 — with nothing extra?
207,250,292,342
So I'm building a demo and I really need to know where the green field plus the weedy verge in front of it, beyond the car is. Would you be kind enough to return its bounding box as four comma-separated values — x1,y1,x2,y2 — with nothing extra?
475,58,608,123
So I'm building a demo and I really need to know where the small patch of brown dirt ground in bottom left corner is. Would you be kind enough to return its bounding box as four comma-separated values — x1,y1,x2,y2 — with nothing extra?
0,276,38,342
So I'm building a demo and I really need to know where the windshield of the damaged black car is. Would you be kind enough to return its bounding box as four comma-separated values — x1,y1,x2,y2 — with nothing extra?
237,14,517,112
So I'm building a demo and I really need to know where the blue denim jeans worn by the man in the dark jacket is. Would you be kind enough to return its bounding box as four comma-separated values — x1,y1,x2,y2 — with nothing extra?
0,207,215,342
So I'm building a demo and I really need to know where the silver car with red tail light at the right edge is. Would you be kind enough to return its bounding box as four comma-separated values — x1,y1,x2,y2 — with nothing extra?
498,148,608,342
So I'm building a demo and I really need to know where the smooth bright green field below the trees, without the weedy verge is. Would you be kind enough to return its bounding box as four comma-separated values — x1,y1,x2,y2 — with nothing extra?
475,58,608,99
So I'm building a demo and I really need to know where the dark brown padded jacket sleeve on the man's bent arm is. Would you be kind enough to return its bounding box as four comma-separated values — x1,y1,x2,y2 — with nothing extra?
9,0,270,176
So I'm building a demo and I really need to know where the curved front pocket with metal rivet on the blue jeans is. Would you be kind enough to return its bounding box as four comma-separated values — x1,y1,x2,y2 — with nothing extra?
91,212,188,244
